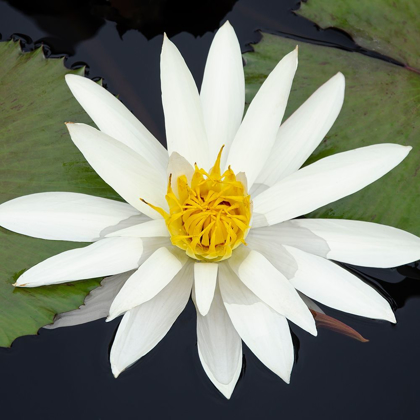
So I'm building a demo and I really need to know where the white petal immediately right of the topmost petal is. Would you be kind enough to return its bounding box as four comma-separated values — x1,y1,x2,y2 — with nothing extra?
227,49,297,188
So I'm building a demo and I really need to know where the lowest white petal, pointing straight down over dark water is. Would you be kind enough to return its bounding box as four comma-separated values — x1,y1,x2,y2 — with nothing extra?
196,287,242,399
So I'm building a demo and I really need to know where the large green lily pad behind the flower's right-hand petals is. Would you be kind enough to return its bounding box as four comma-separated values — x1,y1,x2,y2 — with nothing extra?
245,34,420,236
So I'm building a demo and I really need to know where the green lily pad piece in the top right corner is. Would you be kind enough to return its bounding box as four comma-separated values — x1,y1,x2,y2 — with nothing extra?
296,0,420,71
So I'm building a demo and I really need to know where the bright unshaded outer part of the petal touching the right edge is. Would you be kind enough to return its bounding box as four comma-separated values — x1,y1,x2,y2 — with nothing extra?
290,219,420,268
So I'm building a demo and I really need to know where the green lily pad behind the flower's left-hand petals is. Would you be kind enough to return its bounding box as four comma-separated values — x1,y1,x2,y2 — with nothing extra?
0,41,120,346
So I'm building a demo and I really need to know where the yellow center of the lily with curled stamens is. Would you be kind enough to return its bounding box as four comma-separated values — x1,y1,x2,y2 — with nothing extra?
147,147,252,262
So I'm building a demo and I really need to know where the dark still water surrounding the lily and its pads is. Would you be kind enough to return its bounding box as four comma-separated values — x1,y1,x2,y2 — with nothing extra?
0,0,420,420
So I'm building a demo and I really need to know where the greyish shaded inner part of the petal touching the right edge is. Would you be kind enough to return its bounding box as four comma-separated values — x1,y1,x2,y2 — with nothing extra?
247,223,330,258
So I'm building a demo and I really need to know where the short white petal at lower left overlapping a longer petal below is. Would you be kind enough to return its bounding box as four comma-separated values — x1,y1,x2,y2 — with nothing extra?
107,248,188,321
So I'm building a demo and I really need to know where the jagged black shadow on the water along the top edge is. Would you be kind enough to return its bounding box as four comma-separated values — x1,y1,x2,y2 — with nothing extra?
1,0,237,55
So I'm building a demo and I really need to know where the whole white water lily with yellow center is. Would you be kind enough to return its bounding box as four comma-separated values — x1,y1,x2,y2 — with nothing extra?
0,23,420,398
